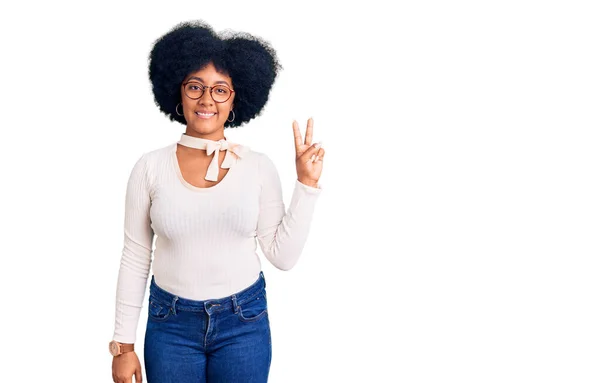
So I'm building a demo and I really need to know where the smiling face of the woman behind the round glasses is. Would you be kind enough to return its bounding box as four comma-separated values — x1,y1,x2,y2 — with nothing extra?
181,63,235,141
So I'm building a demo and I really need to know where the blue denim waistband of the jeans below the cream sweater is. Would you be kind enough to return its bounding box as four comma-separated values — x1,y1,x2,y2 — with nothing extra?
150,271,266,312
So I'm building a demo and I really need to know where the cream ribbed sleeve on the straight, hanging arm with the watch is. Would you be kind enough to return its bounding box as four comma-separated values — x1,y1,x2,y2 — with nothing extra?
113,155,154,343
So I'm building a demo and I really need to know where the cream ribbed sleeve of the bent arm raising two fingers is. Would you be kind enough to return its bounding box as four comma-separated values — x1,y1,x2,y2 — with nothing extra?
257,154,322,270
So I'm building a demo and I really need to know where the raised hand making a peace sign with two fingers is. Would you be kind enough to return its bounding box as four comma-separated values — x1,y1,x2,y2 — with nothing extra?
292,118,325,187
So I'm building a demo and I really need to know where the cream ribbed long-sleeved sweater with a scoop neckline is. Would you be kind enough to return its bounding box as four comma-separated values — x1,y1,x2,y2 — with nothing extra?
113,143,322,343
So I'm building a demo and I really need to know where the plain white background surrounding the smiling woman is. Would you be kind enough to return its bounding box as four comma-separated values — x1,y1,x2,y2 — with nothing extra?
0,1,600,383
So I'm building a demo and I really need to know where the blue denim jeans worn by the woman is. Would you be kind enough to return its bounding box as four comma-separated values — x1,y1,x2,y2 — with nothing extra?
144,271,271,383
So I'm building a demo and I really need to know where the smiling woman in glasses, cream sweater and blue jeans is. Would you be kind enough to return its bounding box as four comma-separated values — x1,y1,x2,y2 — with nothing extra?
110,22,325,383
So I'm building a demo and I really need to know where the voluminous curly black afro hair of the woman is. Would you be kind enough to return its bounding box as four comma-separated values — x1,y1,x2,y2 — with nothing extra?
148,20,282,128
